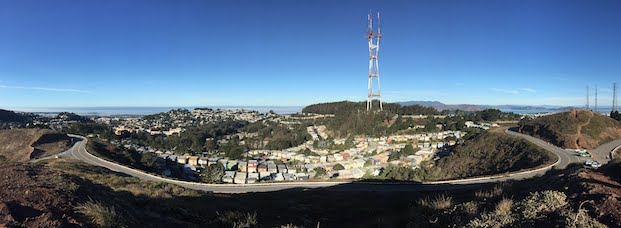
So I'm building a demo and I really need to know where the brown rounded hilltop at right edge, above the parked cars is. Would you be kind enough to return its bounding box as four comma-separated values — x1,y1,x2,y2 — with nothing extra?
519,110,621,149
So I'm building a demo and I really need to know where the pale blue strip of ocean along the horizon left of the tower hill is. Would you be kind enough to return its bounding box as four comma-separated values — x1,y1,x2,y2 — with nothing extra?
10,106,304,116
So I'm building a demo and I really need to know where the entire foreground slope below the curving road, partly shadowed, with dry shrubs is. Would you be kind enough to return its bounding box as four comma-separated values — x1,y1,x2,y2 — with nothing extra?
0,159,621,227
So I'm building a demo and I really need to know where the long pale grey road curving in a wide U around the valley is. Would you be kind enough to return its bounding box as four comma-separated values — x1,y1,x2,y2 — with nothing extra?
50,130,621,193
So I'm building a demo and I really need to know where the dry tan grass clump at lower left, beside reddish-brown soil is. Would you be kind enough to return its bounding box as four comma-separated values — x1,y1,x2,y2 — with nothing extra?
75,199,121,227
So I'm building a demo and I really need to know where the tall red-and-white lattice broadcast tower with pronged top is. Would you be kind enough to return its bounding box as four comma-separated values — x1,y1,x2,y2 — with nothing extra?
367,12,383,111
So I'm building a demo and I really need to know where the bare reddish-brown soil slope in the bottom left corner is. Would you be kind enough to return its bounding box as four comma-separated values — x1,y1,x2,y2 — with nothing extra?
0,164,84,227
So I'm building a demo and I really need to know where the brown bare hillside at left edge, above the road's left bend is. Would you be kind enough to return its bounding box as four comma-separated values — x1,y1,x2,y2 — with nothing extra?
0,128,71,162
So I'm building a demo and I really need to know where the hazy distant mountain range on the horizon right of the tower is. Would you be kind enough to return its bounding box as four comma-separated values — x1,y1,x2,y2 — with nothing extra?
399,101,577,111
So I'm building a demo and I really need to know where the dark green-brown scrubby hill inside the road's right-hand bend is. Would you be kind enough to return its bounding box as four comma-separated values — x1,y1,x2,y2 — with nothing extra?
418,132,556,180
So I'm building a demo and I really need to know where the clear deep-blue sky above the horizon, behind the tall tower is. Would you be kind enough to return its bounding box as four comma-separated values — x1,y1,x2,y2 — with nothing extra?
0,0,621,108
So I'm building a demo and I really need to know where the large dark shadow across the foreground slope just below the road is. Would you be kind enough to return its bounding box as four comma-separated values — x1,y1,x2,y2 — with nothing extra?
58,160,612,227
